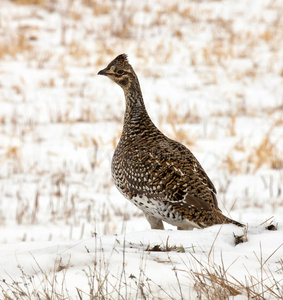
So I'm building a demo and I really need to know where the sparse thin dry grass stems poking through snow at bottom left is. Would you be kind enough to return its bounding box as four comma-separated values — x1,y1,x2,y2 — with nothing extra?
0,238,189,300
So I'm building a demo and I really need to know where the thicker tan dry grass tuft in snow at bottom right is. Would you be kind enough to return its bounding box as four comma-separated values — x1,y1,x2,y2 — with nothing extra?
190,231,283,300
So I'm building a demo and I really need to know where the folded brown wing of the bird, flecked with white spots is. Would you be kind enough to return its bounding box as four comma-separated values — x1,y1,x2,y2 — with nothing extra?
123,139,218,209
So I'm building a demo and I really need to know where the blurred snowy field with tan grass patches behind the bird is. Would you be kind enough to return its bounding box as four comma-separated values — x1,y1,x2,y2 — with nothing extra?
0,0,283,243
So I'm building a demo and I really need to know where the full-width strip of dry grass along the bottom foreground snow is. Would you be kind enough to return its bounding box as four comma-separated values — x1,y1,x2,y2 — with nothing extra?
0,235,283,300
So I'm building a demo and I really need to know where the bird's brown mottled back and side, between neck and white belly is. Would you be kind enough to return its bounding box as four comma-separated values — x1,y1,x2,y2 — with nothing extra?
112,110,218,209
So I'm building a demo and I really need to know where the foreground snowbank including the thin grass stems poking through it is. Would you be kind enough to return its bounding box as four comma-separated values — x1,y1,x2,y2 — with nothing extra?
0,225,283,299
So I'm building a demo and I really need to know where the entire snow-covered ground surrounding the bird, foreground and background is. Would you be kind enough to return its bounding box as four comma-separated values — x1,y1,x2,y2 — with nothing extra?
0,0,283,299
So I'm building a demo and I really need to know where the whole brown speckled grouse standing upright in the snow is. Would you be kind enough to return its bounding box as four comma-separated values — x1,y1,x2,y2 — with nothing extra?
98,54,244,230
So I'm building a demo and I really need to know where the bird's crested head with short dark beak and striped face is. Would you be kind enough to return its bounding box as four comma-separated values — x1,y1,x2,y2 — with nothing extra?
98,54,137,90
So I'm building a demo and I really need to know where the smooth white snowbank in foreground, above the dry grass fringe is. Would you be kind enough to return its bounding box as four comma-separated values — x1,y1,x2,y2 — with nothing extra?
0,225,283,299
